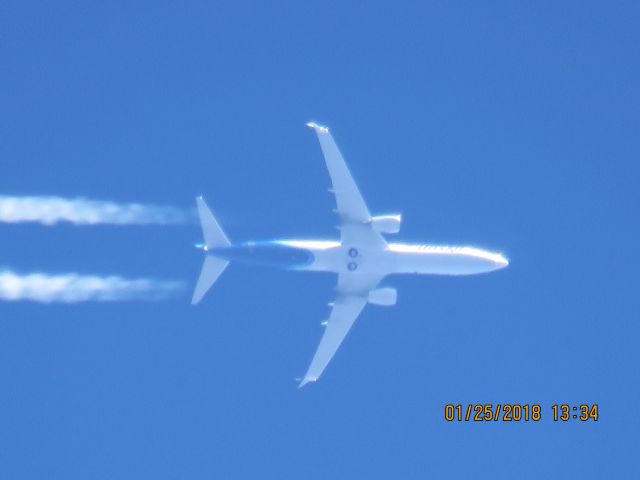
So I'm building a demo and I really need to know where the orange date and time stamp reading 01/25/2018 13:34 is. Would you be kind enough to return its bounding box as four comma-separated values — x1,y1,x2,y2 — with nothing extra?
444,403,599,422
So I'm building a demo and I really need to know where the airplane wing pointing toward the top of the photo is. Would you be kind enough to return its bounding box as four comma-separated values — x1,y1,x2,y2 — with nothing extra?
307,122,386,249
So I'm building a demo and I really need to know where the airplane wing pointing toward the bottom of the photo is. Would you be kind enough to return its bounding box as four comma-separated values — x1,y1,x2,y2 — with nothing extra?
298,272,382,388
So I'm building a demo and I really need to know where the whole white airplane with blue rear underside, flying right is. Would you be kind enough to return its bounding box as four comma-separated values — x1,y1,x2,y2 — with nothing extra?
191,122,509,388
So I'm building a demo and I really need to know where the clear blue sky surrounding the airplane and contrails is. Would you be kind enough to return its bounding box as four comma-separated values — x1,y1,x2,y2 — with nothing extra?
0,1,640,479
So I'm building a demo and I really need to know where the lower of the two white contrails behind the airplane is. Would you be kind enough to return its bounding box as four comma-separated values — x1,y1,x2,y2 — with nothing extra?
0,270,183,303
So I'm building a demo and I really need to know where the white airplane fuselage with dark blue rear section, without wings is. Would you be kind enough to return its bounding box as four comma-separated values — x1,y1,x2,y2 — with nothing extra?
208,240,509,276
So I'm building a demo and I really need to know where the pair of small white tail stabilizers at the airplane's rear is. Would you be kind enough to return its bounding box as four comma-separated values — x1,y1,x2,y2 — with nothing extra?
191,197,231,305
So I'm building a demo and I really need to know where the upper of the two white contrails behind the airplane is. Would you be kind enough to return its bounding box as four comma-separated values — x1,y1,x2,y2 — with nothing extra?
0,196,192,225
